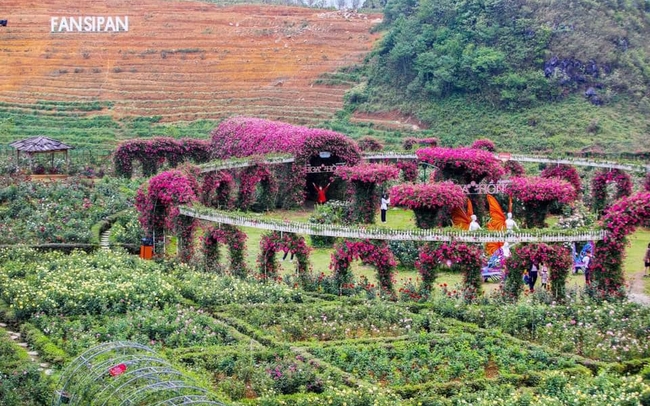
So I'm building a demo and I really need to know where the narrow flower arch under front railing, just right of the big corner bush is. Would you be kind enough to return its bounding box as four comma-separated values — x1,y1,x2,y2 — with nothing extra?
201,224,247,277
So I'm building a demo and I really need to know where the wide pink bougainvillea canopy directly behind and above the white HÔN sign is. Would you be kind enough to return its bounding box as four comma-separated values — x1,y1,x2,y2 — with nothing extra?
415,147,505,183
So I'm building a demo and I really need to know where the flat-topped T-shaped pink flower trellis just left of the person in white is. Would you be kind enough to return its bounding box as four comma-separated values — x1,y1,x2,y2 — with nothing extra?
334,164,399,224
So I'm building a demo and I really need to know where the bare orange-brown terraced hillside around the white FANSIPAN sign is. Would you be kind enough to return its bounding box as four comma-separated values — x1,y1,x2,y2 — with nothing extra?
0,0,381,128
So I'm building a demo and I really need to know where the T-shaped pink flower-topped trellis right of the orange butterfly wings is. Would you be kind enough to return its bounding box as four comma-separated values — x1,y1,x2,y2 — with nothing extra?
506,176,577,228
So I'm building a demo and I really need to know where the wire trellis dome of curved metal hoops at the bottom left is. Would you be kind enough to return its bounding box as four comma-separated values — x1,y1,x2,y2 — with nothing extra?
52,341,225,406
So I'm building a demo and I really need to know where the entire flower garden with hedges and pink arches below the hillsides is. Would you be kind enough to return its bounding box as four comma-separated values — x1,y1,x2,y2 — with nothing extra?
0,117,650,405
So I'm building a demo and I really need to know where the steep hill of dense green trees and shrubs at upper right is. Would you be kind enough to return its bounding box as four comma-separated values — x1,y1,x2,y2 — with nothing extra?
346,0,650,152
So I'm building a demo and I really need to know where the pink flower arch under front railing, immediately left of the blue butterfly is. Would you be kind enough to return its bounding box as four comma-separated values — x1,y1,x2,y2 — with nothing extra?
415,241,482,294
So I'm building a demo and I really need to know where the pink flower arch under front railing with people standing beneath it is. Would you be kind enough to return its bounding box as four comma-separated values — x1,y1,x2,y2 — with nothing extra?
503,243,573,301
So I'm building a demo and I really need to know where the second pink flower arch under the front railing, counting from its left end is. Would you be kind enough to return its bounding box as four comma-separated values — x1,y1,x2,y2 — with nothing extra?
257,231,310,280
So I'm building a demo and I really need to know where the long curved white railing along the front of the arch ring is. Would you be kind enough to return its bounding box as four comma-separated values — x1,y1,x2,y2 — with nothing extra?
180,206,607,243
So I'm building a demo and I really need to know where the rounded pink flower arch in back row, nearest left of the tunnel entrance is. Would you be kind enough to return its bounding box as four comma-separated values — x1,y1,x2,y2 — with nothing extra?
237,164,278,211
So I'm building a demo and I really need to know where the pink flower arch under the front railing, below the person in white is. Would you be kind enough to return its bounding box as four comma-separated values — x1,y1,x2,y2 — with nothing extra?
330,240,397,296
